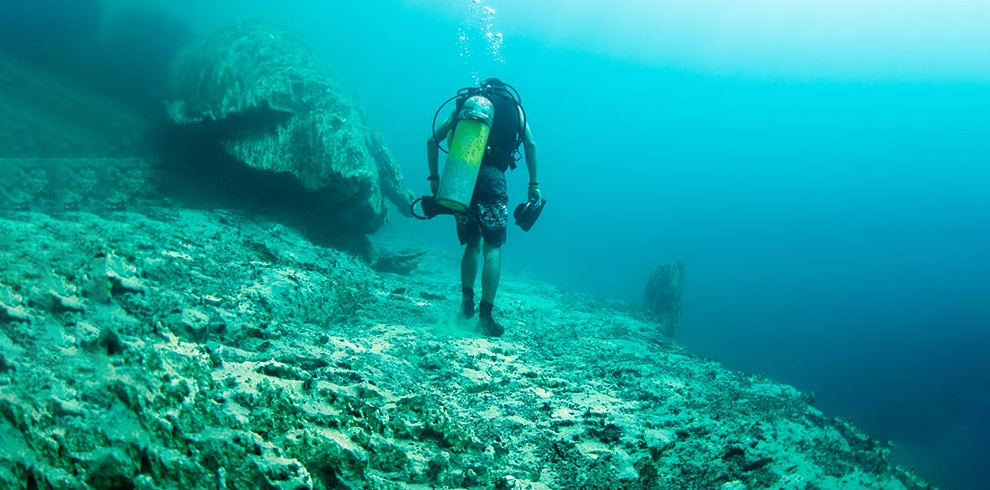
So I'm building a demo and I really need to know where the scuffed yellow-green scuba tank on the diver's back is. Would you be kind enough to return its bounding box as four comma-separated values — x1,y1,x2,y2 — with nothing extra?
437,95,495,211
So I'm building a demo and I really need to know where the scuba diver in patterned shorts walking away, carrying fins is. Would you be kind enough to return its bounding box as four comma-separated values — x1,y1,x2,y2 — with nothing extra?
424,78,546,337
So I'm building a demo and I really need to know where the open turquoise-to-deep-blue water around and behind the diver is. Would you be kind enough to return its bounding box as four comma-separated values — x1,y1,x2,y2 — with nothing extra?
7,0,990,489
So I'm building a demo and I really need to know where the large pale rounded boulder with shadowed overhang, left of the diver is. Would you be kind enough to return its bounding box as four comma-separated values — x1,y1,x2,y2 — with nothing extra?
167,20,410,234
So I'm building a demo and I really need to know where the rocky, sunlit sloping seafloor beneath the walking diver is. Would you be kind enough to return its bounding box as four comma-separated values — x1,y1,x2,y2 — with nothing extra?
0,207,933,490
